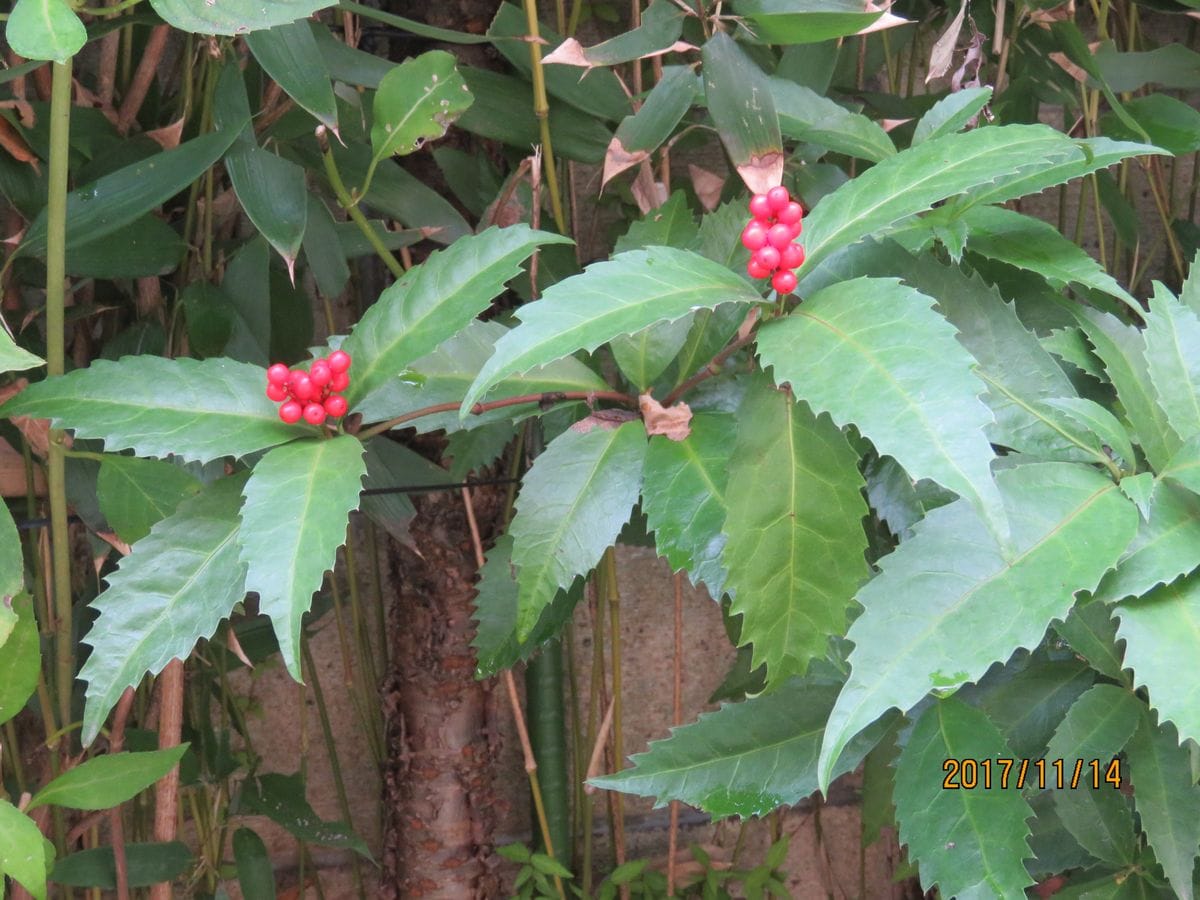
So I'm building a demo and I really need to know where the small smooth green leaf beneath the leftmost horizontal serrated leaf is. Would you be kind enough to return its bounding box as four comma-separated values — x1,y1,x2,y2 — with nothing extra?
96,456,200,544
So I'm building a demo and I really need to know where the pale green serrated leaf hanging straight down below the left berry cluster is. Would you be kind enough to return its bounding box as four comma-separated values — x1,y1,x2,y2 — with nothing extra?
238,434,366,682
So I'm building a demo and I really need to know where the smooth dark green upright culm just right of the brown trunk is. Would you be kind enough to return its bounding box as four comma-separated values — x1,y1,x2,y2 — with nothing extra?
526,638,572,868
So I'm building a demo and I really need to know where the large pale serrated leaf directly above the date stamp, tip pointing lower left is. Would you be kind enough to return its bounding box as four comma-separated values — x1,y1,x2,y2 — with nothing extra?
822,463,1138,784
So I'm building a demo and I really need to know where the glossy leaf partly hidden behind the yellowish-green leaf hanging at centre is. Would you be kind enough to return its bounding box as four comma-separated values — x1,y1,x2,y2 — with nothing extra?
642,413,736,598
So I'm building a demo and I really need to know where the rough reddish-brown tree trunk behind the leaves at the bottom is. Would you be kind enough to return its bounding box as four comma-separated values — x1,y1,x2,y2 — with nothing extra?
380,492,498,900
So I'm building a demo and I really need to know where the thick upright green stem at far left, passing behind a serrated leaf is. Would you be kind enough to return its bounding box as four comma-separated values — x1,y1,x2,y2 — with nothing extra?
46,60,74,739
